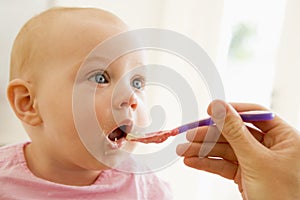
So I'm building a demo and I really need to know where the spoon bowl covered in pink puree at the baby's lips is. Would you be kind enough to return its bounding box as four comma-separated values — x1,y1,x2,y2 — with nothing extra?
126,128,179,144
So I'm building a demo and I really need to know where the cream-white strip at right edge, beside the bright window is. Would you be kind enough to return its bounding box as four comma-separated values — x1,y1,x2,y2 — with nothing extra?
272,0,300,129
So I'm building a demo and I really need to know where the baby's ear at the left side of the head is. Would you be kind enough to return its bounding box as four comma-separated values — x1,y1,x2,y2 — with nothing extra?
7,79,42,126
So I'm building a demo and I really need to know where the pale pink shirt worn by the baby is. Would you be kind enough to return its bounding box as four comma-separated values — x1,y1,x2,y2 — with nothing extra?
0,144,172,200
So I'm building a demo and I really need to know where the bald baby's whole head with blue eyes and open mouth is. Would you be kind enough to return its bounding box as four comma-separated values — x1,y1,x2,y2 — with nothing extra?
8,8,145,170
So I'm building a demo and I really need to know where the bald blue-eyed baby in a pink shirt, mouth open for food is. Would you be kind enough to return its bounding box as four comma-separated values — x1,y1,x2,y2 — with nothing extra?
0,8,171,199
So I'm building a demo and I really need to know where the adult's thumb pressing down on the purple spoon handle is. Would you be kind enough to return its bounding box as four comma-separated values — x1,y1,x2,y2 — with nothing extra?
208,100,258,158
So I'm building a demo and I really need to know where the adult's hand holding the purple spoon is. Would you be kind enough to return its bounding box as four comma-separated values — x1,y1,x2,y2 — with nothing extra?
177,100,300,200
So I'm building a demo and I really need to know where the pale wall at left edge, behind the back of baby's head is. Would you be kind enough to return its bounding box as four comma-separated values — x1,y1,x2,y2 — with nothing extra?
0,0,49,145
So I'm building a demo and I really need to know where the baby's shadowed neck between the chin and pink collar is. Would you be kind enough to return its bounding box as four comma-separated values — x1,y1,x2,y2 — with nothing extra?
24,144,101,186
